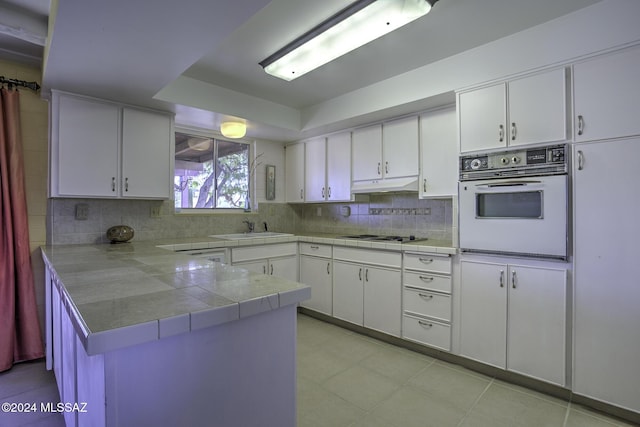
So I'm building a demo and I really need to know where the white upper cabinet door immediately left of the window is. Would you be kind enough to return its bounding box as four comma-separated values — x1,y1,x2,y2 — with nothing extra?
121,108,173,199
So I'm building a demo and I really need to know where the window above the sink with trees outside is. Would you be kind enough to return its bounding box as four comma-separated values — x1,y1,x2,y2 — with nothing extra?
174,132,249,210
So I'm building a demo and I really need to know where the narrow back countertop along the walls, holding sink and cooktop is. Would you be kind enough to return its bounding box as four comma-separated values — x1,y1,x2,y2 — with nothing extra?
156,233,458,255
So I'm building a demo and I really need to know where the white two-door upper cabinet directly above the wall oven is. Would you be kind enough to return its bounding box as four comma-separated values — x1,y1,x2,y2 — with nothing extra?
458,68,569,152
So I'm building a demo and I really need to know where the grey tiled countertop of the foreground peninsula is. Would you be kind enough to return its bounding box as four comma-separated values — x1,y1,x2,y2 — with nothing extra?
41,242,311,355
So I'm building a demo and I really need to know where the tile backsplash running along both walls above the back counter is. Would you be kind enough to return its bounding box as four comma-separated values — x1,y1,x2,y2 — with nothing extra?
47,193,457,244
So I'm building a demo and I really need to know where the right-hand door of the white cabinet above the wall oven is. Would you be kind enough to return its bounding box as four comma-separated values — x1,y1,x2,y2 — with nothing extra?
508,68,567,145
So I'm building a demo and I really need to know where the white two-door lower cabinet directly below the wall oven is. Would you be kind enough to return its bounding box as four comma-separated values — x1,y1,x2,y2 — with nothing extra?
460,260,567,386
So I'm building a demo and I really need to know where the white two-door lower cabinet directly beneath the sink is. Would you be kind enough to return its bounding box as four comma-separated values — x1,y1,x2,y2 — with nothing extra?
231,243,298,282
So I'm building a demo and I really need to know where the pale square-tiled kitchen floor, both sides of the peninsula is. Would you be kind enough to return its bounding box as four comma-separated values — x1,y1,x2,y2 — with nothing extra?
0,315,632,427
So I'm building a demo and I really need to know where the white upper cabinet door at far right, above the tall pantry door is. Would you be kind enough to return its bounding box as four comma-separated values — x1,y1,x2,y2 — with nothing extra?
573,47,640,141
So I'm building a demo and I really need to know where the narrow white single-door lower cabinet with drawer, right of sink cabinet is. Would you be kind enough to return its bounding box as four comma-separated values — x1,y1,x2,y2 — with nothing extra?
300,243,333,316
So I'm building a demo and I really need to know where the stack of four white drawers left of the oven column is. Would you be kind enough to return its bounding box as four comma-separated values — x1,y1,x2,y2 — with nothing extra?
402,253,451,351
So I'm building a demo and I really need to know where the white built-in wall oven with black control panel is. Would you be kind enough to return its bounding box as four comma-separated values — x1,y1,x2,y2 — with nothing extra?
459,144,569,259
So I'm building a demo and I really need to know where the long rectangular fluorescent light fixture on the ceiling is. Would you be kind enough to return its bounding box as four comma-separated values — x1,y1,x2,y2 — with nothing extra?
260,0,438,81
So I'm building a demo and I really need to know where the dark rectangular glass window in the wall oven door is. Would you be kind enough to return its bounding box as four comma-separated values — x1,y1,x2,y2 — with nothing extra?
476,191,542,218
